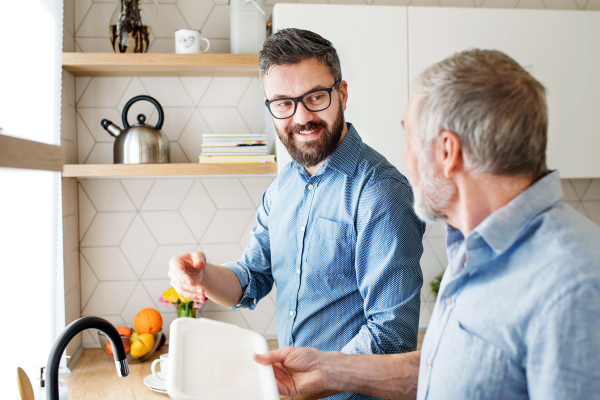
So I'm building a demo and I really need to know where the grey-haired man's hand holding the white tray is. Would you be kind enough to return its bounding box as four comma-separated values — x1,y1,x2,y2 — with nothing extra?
253,347,327,397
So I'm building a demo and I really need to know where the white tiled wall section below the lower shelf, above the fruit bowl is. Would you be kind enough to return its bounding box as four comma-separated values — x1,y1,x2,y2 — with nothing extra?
73,176,275,346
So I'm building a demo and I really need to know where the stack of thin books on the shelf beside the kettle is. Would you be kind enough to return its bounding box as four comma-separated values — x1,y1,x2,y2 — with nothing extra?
199,134,275,164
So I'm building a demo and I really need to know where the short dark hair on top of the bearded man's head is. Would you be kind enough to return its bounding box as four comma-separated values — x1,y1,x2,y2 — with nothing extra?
258,28,342,82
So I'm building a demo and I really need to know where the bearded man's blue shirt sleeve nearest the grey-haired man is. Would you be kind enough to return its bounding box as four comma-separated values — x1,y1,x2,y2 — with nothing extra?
342,178,425,354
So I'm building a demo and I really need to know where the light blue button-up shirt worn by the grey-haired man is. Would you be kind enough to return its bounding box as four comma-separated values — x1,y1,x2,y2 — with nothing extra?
417,172,600,400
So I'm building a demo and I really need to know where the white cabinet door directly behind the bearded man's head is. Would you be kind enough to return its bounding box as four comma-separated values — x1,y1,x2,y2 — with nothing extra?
274,4,408,173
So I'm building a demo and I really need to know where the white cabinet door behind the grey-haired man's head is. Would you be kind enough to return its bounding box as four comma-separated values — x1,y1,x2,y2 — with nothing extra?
408,7,600,178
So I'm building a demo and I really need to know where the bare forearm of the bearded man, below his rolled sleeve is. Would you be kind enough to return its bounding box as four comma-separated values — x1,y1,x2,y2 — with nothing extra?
201,264,244,307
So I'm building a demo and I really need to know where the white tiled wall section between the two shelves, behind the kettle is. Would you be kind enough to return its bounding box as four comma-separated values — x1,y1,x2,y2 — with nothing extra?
76,77,266,164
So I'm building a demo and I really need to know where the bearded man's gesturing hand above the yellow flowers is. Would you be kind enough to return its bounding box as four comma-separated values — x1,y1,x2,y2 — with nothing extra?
169,251,206,302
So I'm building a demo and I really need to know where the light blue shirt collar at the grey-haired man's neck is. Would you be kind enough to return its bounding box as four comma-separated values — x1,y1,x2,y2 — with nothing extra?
476,171,563,254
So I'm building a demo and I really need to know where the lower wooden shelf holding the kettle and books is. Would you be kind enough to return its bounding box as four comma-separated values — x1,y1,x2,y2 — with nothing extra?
62,163,277,178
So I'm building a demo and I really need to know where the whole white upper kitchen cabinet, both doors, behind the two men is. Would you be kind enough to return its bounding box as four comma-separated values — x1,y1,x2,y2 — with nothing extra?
274,4,600,178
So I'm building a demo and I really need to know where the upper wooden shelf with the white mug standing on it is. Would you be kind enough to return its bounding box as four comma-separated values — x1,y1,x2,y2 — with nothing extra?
63,53,258,77
